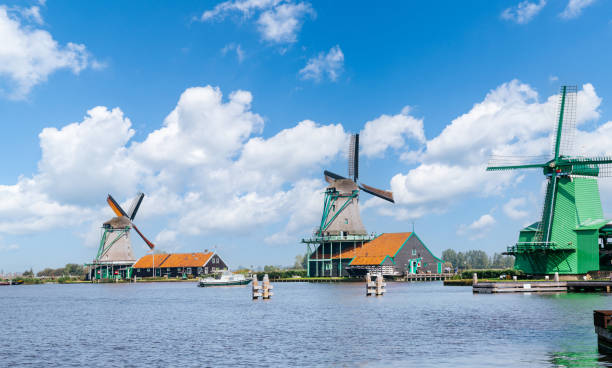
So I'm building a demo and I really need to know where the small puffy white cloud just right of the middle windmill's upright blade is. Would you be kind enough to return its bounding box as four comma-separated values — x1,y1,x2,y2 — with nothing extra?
360,106,425,156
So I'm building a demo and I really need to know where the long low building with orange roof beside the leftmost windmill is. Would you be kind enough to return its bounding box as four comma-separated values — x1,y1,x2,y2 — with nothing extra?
132,252,227,277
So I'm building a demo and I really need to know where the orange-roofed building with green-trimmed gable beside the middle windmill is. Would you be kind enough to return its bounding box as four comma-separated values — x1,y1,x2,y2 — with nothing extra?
346,232,444,276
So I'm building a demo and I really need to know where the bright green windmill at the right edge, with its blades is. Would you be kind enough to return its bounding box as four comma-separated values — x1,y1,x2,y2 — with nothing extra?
487,86,612,274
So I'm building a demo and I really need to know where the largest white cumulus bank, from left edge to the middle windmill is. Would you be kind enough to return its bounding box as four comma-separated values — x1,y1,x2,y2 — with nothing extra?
0,86,348,249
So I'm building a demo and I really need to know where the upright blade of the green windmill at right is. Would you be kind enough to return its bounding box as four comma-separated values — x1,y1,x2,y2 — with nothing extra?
552,86,578,158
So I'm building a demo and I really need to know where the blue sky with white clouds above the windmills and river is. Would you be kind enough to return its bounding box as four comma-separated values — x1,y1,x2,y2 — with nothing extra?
0,0,612,271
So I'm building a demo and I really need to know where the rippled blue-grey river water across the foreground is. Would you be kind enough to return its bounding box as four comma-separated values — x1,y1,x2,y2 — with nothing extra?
0,282,612,367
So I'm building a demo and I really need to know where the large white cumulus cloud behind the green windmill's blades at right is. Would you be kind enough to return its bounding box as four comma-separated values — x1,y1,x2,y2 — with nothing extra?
381,81,609,219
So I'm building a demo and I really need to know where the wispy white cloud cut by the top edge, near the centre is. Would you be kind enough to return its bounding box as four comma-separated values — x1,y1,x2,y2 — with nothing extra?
200,0,315,44
